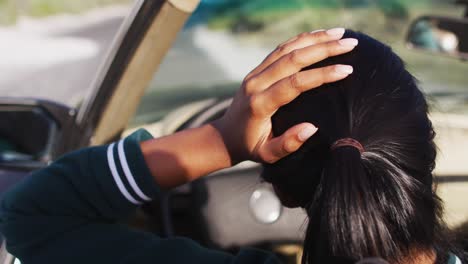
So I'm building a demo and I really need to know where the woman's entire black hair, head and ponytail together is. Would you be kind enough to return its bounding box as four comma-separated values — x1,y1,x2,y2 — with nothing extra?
262,31,454,264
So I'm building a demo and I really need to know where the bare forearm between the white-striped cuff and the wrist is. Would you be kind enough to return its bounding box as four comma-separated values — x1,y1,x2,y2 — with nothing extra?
141,124,235,189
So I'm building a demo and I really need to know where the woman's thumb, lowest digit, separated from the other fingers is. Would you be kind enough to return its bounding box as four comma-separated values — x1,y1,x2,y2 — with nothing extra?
259,123,318,163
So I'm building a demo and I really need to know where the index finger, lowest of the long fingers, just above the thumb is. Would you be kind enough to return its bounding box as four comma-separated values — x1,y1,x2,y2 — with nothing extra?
251,64,353,116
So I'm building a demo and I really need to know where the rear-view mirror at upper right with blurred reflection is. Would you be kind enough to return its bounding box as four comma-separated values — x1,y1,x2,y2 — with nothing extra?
406,16,468,60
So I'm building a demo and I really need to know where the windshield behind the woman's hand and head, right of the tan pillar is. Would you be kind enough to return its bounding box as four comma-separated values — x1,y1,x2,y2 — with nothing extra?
130,0,468,126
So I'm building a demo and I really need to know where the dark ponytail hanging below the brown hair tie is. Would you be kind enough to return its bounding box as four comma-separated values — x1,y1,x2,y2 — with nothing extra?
303,147,440,263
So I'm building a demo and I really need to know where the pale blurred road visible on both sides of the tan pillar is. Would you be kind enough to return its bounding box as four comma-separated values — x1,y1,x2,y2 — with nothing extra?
0,7,268,109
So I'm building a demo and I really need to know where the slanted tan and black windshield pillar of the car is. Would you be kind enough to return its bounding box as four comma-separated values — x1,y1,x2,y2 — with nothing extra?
77,0,199,146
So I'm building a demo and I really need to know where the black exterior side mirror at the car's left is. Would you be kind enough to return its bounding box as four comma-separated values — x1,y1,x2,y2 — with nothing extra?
0,98,74,169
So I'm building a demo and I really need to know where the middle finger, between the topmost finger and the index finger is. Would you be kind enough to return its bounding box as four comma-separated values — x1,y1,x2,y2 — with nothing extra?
250,38,358,92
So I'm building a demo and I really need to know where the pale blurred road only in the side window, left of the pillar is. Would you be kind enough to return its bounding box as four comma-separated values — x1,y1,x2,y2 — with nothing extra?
0,7,125,105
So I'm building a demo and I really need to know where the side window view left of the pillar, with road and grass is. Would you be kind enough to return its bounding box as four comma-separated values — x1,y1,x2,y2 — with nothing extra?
0,0,134,107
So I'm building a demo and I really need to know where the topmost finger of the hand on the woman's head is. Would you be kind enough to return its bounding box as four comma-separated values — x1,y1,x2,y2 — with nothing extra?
247,28,345,78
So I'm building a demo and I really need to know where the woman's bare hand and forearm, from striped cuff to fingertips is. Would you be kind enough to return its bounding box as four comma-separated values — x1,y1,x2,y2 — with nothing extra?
141,29,357,189
